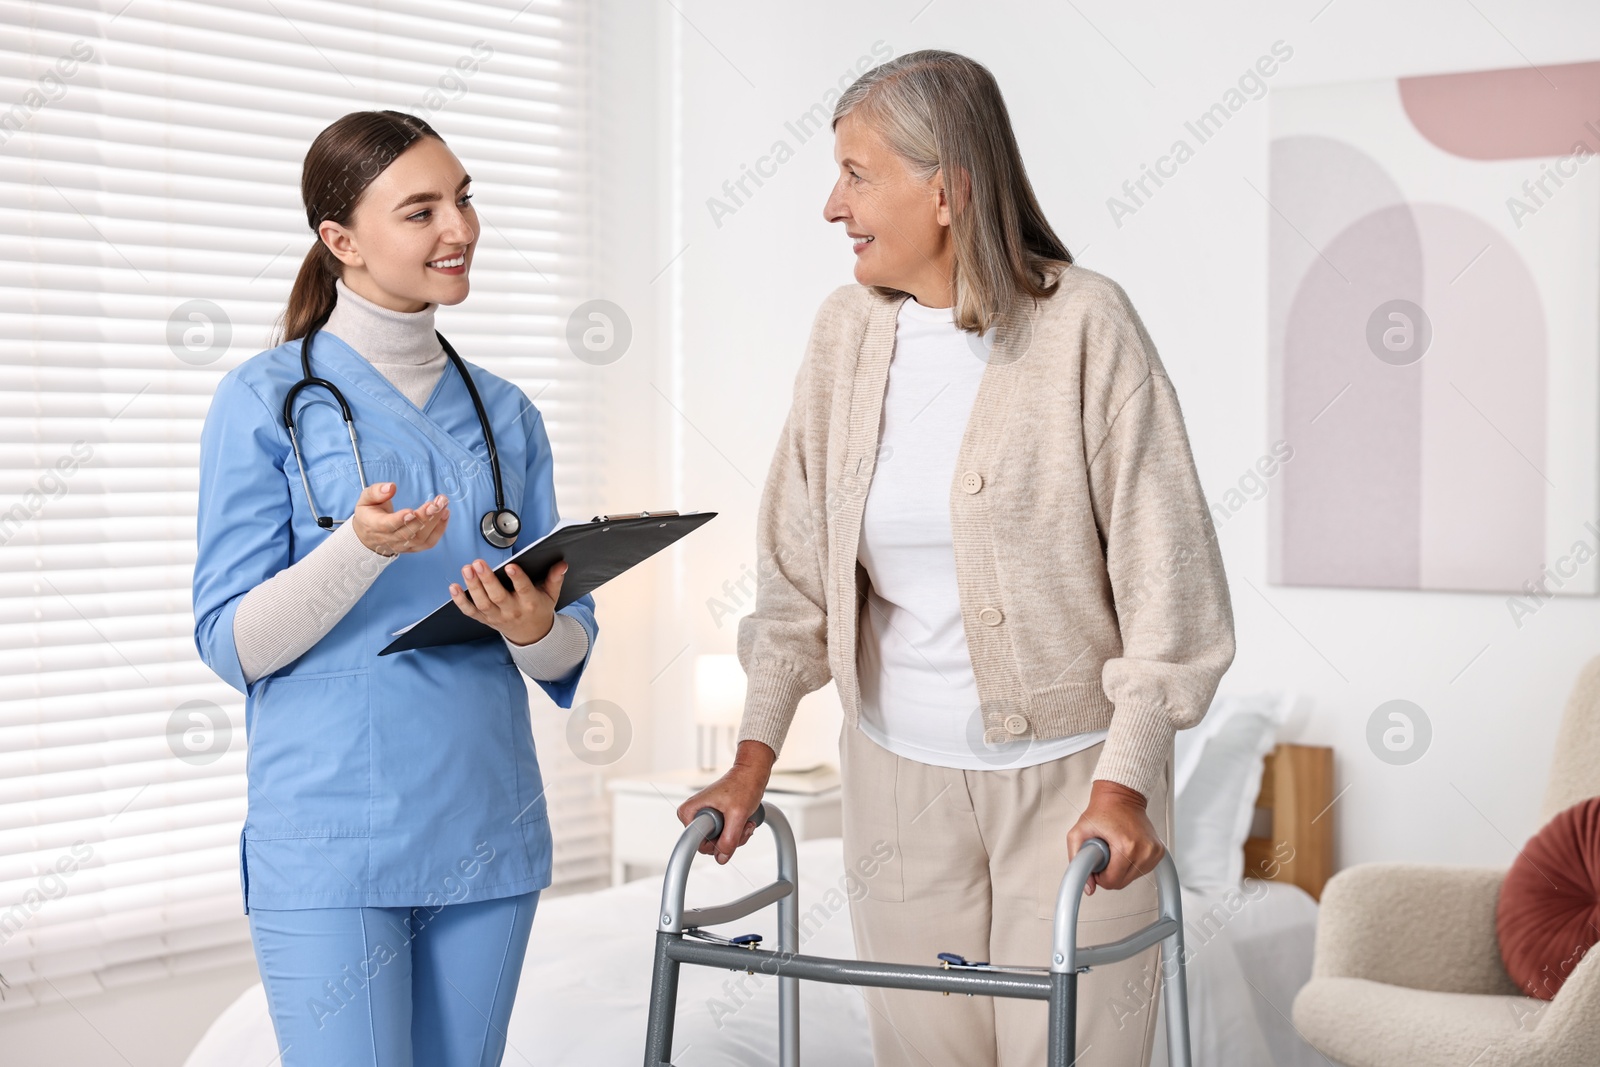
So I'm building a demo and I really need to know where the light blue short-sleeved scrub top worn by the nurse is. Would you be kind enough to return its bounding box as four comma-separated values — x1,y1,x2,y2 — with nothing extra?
194,331,598,912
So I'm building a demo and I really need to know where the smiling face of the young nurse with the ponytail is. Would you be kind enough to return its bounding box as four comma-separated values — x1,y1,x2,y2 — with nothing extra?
317,138,478,312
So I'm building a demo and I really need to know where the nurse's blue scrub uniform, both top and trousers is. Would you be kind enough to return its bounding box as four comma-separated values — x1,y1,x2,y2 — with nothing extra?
194,333,598,1067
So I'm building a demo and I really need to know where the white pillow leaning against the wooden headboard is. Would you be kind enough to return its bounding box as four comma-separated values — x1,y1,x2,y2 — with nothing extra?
1171,693,1290,893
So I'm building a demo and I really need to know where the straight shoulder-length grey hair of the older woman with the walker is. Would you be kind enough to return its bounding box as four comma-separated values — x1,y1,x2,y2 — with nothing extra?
834,48,1072,330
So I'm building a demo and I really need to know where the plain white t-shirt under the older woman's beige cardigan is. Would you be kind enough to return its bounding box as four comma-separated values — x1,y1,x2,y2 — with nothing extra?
856,298,1107,771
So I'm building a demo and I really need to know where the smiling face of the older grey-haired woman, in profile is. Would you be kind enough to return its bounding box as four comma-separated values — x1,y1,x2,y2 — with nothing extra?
822,112,954,307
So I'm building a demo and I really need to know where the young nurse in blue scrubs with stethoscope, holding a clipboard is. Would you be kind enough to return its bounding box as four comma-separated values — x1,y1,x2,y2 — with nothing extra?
194,110,597,1067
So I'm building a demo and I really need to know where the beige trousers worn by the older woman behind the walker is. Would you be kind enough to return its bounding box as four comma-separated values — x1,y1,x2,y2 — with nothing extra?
840,723,1173,1067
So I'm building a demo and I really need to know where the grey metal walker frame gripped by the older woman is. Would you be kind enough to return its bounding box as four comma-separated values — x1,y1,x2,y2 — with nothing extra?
645,803,1192,1067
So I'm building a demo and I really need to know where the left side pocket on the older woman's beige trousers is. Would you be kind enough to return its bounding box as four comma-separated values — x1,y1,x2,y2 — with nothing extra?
838,721,906,901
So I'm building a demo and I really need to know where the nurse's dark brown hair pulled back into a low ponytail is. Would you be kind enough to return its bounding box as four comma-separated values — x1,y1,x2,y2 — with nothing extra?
274,110,443,344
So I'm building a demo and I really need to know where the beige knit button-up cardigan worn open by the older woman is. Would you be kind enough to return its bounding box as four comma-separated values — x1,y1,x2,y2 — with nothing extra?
739,266,1234,797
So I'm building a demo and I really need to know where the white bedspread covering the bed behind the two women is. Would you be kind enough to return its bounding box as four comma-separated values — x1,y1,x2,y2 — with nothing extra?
186,837,1326,1067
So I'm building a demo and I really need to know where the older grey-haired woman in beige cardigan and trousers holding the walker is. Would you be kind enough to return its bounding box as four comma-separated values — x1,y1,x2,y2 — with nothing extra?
678,51,1234,1067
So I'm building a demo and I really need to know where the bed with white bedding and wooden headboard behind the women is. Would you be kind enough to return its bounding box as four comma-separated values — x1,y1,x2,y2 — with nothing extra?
186,697,1334,1067
